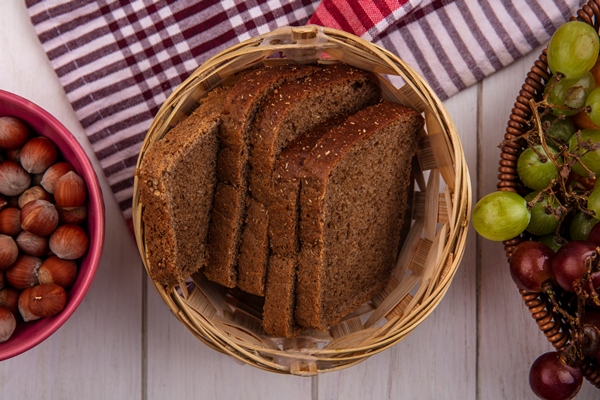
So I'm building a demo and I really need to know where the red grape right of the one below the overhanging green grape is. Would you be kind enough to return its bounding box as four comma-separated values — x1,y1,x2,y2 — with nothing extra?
551,240,598,292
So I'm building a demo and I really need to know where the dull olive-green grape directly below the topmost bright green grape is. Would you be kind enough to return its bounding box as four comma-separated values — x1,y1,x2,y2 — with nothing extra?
544,72,596,116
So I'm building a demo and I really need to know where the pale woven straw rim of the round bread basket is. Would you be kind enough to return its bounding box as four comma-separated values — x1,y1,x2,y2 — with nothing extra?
132,25,472,375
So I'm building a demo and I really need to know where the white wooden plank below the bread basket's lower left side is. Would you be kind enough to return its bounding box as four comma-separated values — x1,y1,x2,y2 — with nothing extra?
147,281,312,400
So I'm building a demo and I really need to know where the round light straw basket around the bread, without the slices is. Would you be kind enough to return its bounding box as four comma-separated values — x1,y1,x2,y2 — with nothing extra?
133,26,471,375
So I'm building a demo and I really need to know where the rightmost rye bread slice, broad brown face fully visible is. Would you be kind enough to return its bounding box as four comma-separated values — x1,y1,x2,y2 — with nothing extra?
295,102,423,330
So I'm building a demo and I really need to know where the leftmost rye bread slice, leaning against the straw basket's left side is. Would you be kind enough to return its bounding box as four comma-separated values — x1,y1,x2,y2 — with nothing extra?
136,88,227,288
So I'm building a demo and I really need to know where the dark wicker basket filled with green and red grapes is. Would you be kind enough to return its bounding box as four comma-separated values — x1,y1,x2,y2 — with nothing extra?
472,0,600,399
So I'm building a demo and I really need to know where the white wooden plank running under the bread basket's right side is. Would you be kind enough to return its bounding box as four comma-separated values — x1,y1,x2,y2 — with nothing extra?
318,83,477,400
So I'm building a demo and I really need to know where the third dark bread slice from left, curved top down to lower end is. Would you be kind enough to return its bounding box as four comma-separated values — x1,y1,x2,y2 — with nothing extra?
238,63,380,295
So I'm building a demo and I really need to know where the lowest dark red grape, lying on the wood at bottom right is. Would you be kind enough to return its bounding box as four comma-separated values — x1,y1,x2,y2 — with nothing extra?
529,351,583,400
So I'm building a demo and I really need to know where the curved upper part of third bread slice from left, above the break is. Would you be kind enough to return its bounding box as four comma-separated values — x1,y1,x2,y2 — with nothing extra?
248,63,381,204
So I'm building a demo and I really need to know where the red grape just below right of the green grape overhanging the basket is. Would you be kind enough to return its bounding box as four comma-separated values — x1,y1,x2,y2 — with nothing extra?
509,241,554,293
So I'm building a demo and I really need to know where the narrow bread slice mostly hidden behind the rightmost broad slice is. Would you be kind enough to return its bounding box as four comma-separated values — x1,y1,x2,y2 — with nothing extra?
263,114,347,338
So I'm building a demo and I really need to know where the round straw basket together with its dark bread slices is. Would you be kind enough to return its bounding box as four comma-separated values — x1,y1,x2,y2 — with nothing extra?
133,25,471,375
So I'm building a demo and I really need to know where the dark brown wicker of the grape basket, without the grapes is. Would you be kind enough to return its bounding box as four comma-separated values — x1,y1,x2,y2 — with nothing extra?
497,0,600,388
